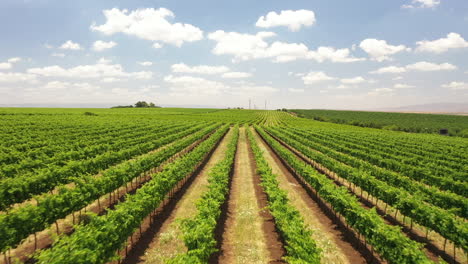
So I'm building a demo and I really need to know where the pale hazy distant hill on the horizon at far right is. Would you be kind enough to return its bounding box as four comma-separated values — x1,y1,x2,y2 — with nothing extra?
376,102,468,114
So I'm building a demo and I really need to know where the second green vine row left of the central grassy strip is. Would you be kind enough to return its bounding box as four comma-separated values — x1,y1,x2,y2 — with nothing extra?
37,126,228,264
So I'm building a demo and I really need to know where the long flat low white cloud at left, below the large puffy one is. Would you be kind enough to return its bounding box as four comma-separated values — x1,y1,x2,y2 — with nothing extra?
27,59,153,79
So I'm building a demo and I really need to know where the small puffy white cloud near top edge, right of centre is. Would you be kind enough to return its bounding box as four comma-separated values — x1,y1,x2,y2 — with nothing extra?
255,9,315,31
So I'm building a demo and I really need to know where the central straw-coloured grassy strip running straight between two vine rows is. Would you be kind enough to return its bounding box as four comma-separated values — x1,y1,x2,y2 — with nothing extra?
218,127,273,264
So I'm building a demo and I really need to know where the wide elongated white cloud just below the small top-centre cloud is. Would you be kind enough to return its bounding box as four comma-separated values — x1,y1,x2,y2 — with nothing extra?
208,30,364,62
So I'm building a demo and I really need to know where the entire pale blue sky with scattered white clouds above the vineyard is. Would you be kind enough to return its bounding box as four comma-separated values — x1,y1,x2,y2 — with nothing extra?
0,0,468,110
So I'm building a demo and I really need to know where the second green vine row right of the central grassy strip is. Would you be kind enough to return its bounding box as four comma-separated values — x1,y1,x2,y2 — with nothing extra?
256,127,432,263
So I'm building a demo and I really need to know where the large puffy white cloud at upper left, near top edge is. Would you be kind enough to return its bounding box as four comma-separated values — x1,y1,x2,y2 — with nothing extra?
91,8,203,47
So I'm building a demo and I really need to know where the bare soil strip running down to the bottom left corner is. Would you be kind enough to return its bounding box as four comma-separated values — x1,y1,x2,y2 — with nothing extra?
0,132,212,264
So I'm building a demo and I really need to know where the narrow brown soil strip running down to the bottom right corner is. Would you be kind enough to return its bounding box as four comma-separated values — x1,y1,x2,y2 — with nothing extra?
264,130,466,263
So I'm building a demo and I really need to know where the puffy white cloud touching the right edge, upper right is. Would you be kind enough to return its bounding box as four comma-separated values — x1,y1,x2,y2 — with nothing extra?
416,32,468,54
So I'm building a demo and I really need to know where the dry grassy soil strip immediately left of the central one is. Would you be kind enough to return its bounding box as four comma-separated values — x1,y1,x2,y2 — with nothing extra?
130,130,232,263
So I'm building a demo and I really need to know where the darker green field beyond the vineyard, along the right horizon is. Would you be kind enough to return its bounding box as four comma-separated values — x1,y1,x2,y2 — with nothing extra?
292,110,468,137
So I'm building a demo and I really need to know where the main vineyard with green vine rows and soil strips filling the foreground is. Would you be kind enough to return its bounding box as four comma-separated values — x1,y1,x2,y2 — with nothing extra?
0,108,468,264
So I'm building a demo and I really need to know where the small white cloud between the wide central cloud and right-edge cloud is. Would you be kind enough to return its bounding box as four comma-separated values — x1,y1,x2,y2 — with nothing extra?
359,39,411,61
